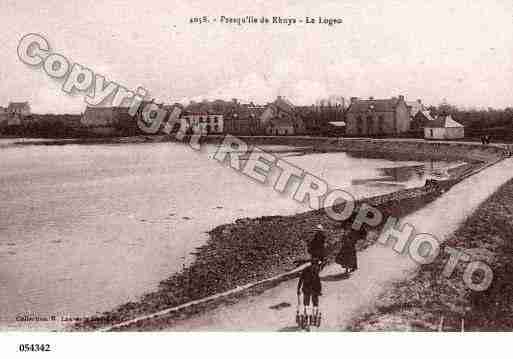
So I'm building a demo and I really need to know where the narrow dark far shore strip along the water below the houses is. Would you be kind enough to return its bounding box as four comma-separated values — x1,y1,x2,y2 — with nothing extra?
8,134,505,163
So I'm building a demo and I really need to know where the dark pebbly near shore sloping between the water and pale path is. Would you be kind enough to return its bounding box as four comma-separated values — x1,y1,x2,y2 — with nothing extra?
72,173,468,330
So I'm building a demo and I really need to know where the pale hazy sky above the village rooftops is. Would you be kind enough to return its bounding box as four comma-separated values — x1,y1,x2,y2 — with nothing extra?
0,0,513,113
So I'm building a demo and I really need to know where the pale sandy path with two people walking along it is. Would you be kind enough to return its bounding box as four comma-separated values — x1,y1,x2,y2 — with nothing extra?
161,159,513,331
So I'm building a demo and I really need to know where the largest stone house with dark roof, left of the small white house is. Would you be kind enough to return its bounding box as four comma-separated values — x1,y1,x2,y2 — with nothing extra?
346,96,411,136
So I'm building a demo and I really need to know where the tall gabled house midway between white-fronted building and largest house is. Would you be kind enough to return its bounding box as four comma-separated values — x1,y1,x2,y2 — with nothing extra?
260,96,305,136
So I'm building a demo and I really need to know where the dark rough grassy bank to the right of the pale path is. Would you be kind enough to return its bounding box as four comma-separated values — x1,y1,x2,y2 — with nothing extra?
348,180,513,331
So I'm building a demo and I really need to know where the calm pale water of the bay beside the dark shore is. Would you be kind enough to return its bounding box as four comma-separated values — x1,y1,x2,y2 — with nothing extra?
0,140,462,329
